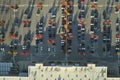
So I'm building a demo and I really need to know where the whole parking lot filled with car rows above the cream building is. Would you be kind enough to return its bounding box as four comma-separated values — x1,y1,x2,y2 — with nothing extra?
0,0,120,75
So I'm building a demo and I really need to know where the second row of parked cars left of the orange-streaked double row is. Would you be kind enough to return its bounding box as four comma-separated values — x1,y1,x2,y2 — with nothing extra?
34,1,45,52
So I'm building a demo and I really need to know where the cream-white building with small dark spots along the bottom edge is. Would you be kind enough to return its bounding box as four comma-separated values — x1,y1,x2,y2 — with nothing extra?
0,64,120,80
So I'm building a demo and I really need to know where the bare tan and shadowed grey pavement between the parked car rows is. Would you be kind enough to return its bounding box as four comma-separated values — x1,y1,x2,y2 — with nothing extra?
0,0,120,75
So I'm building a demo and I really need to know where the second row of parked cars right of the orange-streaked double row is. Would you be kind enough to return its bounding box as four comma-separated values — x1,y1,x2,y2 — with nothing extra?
90,8,100,53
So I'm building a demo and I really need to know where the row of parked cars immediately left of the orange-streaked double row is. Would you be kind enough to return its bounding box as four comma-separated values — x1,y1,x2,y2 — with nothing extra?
47,5,58,53
